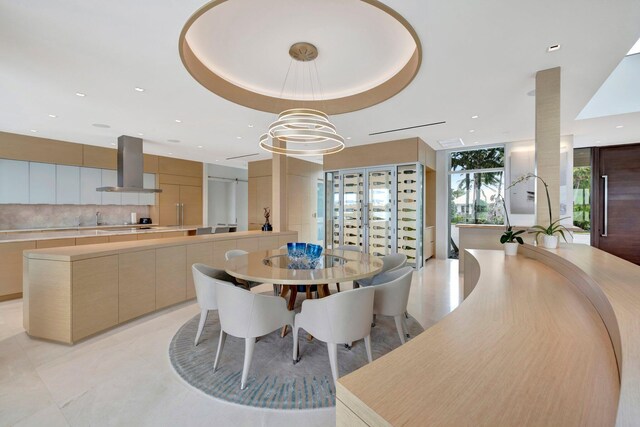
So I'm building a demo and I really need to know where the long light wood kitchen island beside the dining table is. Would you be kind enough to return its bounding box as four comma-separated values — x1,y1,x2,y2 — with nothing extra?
23,231,297,344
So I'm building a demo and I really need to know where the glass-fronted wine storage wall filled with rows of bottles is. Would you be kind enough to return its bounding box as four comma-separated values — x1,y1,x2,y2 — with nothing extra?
325,163,423,268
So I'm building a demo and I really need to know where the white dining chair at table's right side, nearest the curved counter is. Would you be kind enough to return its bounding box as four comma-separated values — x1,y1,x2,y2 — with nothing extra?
369,267,413,344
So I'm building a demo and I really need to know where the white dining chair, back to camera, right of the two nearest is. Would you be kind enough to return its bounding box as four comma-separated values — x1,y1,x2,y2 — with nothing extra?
293,287,375,382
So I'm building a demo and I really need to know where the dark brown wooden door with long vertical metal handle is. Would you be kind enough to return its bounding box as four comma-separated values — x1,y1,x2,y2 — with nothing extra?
592,144,640,265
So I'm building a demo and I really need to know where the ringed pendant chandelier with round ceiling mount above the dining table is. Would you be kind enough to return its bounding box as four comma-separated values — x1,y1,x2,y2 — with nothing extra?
260,42,344,156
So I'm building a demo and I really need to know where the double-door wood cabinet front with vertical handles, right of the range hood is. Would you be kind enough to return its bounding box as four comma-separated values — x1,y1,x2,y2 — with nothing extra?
159,184,202,225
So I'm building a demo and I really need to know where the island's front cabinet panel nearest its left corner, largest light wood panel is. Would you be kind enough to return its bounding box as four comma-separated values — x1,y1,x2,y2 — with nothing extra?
71,255,118,341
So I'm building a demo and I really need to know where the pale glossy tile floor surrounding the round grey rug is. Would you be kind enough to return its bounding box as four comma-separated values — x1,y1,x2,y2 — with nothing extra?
0,260,462,427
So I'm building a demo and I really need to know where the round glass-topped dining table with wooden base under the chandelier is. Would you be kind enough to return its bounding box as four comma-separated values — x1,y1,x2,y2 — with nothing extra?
225,249,382,336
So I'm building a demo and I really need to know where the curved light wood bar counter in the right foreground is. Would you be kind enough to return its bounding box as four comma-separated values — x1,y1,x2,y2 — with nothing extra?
336,245,640,426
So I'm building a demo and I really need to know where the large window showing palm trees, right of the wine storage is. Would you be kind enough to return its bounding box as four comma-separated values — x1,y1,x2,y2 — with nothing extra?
448,146,505,258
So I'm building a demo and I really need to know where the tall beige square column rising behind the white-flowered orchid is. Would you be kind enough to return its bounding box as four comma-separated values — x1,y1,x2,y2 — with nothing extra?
536,67,560,226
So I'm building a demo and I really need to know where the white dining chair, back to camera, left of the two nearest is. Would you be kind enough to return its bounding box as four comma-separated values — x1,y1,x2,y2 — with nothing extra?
213,283,295,390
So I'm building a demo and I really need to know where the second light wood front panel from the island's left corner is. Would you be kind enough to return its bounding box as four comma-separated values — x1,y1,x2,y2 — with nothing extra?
118,249,156,323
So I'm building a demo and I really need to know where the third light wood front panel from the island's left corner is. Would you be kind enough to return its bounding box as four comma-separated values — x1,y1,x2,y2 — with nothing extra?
156,246,187,309
